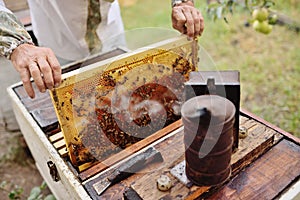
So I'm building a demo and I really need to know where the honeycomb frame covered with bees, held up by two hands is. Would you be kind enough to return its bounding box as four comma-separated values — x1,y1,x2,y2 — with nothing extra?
50,36,198,171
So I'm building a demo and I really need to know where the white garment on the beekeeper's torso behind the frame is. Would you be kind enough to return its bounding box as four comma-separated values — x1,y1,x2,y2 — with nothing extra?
28,0,125,60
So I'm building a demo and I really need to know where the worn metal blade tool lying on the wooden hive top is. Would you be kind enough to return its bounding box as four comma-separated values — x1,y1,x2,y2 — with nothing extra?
93,147,163,196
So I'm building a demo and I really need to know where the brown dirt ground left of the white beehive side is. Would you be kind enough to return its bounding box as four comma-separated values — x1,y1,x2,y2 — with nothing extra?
0,122,49,199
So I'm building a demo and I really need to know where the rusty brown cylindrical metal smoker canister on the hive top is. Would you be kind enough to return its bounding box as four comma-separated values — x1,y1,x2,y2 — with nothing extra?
181,95,235,186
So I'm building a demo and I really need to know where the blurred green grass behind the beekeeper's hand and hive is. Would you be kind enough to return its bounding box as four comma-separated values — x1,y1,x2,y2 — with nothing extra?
121,0,300,137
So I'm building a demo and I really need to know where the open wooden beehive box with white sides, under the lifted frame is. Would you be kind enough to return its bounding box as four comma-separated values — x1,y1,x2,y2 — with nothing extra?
8,37,300,199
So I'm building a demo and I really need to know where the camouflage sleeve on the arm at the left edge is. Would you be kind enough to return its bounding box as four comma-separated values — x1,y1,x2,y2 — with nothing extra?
0,11,33,59
